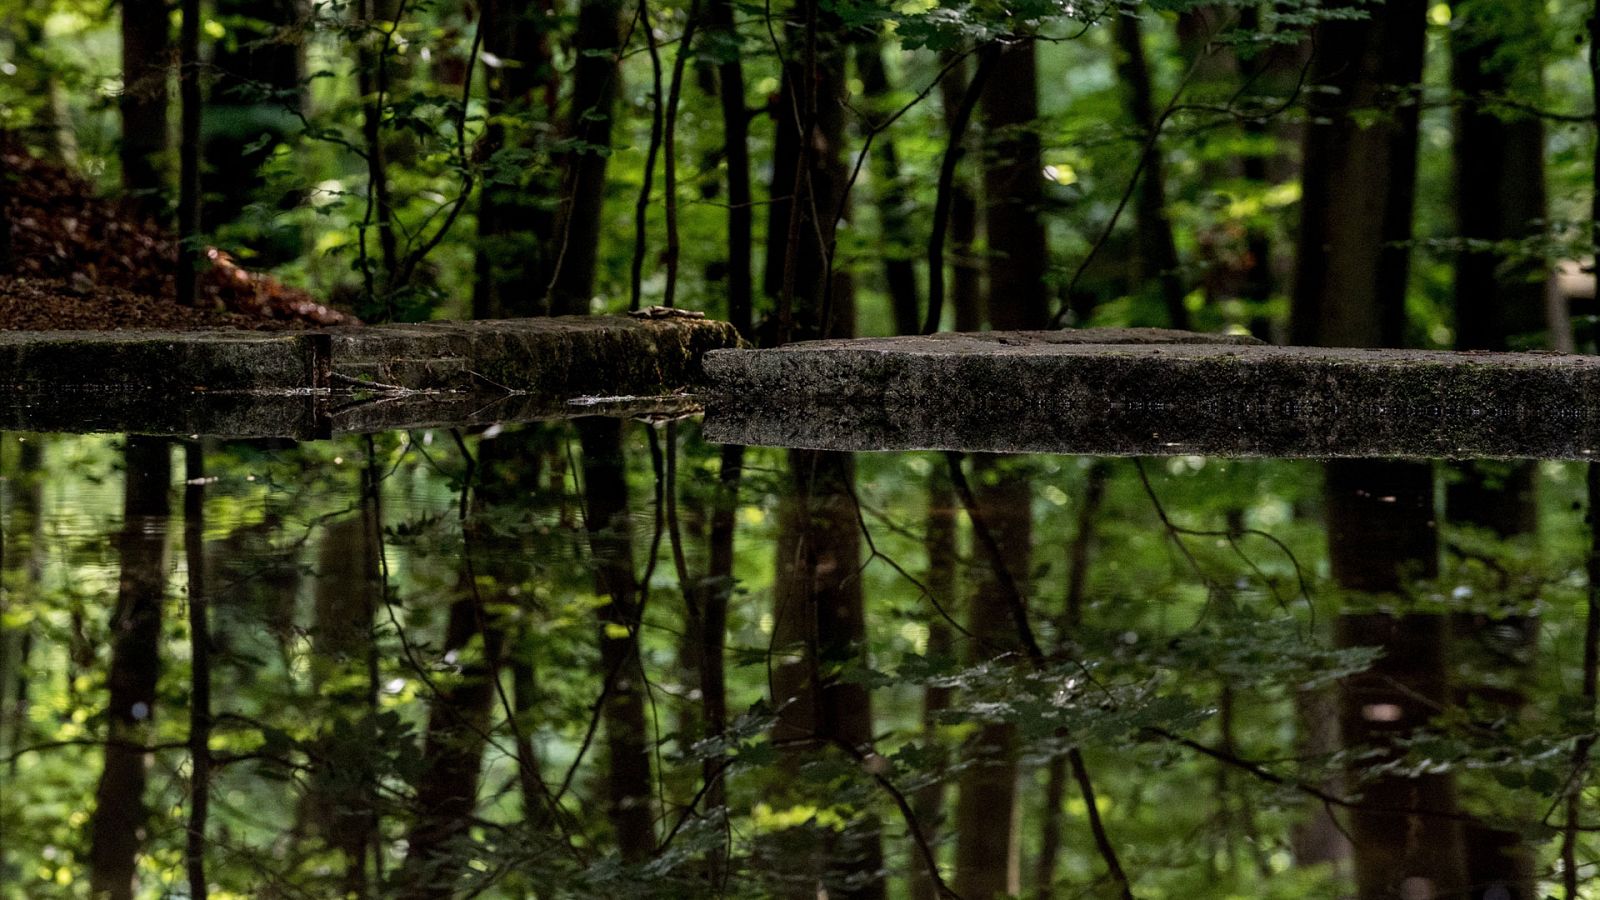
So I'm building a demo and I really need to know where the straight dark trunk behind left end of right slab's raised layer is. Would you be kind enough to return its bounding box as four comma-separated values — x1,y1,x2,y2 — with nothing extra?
982,40,1050,330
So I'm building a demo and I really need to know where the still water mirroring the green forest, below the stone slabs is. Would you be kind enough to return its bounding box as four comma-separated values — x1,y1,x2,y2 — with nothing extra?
0,420,1600,898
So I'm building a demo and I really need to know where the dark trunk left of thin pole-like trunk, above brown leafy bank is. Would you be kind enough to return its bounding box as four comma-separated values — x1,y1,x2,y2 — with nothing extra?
117,0,171,221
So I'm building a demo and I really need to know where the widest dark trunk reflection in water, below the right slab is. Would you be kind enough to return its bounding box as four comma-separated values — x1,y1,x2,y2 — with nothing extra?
1326,460,1467,900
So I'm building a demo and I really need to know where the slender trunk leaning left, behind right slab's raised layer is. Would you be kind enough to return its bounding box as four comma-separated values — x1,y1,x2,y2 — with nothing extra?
1117,14,1189,328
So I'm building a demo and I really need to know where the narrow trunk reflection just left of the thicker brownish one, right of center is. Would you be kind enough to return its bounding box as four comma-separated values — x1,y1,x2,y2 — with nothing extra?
910,466,958,900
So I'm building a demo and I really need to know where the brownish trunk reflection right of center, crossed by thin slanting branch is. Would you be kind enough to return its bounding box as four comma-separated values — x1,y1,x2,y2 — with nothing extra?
955,456,1034,900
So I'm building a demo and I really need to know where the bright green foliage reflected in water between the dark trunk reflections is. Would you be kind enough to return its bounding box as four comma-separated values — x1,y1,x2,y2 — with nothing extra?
0,428,1594,898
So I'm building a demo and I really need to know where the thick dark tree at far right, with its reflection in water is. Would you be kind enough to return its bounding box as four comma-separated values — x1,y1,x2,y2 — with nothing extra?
1446,0,1548,900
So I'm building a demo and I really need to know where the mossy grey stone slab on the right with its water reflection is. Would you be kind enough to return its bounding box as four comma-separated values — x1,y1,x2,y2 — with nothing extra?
706,331,1600,458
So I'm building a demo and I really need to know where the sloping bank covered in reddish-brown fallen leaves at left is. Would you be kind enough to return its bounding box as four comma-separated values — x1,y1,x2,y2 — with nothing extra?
0,147,360,330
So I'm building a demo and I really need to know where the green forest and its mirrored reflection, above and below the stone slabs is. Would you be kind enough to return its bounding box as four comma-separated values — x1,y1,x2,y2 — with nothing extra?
0,0,1600,900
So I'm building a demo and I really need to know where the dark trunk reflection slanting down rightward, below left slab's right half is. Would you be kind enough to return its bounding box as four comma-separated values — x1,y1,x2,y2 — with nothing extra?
578,418,656,862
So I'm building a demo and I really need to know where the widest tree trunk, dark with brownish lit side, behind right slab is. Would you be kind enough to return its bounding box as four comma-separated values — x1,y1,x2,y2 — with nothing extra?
1291,0,1426,348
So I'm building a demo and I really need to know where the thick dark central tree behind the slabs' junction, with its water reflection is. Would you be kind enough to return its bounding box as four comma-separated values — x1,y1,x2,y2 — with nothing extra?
765,0,886,900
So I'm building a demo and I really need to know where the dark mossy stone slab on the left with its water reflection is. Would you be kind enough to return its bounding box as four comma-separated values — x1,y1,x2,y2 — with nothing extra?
0,315,738,437
